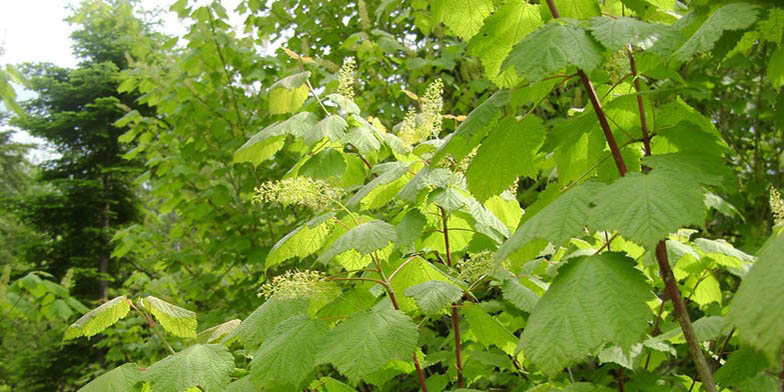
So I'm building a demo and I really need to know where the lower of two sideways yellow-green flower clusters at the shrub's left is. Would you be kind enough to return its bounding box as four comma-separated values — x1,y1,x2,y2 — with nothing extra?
259,270,333,299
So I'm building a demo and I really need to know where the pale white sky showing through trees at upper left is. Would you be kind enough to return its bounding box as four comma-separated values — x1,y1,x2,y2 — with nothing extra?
0,0,239,163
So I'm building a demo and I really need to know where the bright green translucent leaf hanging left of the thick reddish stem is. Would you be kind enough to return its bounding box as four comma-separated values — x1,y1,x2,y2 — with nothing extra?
466,116,545,201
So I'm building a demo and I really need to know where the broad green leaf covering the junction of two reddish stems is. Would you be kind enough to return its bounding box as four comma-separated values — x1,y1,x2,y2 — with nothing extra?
587,170,705,248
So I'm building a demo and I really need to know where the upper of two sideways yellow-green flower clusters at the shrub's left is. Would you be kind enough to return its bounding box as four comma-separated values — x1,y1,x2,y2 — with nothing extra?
253,177,343,210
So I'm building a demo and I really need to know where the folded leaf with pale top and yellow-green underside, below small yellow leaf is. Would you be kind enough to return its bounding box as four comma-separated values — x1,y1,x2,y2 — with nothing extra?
234,112,317,165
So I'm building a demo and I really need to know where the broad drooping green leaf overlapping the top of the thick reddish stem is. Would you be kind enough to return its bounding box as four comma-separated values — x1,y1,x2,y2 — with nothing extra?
501,21,604,82
